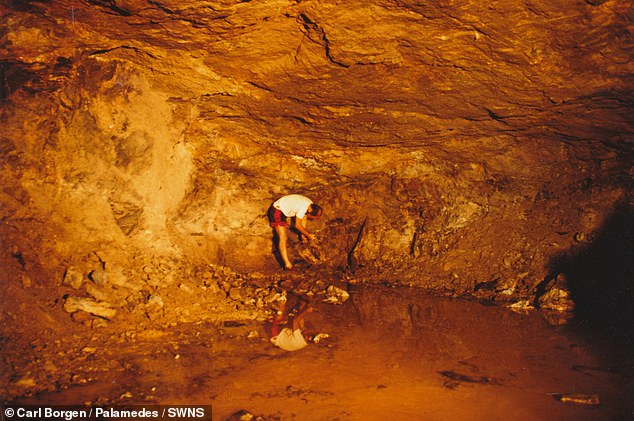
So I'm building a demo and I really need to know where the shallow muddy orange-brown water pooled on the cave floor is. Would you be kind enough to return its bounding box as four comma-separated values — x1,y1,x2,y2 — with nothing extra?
12,287,633,421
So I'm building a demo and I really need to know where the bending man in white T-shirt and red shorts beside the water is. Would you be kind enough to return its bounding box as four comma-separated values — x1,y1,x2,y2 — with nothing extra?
268,194,322,269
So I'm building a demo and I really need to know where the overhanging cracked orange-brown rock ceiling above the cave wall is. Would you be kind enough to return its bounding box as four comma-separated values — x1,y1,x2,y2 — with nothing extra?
2,1,632,150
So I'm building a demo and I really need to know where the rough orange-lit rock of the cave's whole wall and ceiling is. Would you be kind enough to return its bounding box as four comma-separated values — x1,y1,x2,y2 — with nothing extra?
0,0,634,332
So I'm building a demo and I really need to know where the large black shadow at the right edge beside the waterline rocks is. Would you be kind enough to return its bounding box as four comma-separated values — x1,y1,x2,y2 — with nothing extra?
550,201,634,346
